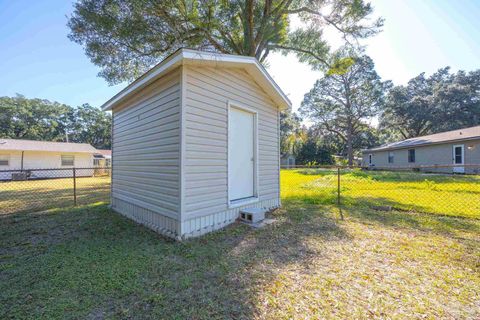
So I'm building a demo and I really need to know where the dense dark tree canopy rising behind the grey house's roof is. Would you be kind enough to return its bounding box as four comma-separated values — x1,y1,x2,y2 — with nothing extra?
380,67,480,140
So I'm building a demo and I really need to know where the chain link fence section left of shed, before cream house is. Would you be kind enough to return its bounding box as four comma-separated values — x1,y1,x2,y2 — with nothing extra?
0,167,111,214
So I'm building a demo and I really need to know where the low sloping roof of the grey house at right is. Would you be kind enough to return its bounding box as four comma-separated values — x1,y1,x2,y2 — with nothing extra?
364,126,480,152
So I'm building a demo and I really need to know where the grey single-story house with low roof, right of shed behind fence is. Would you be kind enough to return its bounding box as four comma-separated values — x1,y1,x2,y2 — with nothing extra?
362,126,480,173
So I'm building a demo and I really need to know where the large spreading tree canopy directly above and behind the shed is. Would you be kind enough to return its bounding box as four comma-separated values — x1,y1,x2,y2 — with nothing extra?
68,0,383,84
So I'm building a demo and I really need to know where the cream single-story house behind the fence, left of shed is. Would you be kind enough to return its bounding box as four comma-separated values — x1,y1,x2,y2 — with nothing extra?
0,139,97,180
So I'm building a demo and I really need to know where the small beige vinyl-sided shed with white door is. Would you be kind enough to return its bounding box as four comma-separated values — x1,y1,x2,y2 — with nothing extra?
102,49,291,239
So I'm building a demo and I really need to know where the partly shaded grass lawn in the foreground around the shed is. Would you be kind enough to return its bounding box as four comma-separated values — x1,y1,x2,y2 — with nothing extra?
0,172,480,319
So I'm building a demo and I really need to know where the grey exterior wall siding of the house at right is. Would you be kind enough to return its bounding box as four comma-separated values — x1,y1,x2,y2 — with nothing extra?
363,139,480,173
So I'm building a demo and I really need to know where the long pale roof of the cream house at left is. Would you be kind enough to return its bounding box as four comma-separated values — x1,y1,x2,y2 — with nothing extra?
0,139,97,153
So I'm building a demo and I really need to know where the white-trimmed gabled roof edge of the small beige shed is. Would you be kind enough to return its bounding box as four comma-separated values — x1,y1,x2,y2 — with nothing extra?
101,49,292,111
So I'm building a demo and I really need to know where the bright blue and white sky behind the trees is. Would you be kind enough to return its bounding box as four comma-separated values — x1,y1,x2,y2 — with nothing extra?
0,0,480,110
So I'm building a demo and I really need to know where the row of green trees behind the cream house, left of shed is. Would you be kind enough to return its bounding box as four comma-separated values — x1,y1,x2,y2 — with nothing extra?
0,95,112,149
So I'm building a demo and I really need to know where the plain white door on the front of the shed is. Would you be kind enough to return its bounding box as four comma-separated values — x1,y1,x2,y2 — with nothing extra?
228,107,256,201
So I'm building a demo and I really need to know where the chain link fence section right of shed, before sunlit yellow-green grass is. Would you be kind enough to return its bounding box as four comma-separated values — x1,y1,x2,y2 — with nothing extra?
281,165,480,217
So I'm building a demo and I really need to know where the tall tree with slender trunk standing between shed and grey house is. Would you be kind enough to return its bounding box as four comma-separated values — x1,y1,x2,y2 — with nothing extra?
300,50,390,165
